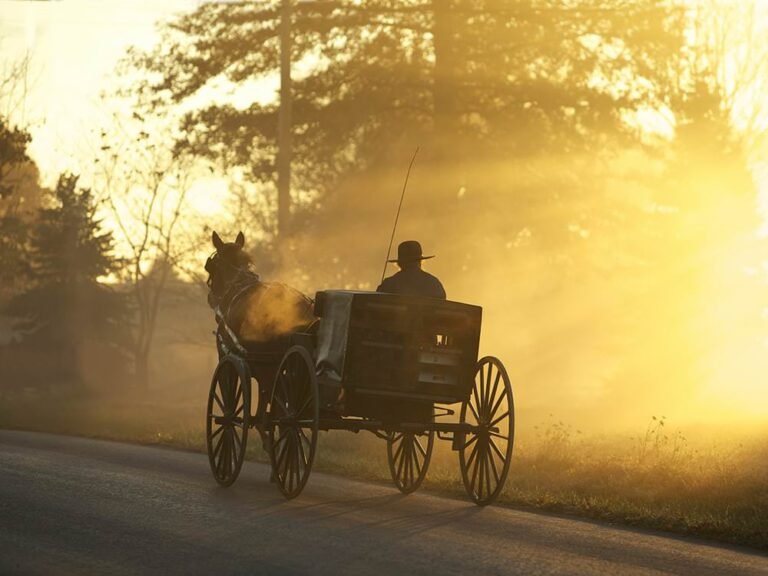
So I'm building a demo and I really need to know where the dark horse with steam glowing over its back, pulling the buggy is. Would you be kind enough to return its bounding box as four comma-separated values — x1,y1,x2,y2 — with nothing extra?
205,232,316,355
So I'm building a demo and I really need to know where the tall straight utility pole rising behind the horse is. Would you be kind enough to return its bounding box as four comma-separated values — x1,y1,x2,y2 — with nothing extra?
277,0,293,241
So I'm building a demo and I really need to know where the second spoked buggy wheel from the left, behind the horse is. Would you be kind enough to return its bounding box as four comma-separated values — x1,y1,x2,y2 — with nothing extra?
268,347,319,498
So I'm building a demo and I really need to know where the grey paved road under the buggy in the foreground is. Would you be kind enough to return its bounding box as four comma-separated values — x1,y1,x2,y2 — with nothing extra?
0,432,768,576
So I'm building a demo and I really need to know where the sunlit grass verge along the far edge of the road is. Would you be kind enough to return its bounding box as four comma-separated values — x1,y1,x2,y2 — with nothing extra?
0,393,768,550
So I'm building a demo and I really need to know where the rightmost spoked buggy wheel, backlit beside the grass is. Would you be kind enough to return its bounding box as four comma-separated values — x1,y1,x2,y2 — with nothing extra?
459,357,515,505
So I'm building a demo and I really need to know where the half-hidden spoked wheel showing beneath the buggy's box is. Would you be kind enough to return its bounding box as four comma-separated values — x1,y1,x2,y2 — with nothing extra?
387,432,435,494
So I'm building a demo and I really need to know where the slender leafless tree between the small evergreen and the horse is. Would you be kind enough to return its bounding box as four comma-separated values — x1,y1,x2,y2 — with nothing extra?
97,113,204,387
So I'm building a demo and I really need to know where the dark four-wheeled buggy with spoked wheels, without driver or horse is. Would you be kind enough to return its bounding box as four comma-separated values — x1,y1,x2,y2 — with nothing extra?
206,234,514,505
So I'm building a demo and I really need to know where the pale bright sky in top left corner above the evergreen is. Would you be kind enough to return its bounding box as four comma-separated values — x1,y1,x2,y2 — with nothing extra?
0,0,200,184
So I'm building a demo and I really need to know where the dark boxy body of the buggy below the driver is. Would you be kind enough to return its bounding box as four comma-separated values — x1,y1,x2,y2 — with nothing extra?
315,290,482,404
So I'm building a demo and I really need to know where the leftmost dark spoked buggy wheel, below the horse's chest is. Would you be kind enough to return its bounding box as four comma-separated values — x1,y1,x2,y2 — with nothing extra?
206,358,251,486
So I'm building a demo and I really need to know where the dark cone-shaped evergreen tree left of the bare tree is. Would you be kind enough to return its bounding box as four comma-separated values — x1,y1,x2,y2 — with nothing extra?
10,174,129,380
